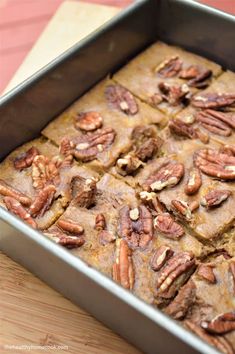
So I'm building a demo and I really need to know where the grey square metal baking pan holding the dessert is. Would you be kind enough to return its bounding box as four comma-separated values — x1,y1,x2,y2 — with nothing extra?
0,0,235,354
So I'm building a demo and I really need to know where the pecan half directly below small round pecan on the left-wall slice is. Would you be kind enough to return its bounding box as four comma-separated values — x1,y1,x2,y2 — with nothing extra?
73,128,116,162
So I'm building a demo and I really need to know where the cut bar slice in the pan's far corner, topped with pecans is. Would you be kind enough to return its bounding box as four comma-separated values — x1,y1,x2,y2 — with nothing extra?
114,42,221,114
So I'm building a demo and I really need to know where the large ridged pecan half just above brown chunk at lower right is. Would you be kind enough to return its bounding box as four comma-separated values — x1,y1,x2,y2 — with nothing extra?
156,252,195,298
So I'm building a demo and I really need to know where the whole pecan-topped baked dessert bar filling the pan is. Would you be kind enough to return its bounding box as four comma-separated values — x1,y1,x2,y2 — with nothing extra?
0,42,235,354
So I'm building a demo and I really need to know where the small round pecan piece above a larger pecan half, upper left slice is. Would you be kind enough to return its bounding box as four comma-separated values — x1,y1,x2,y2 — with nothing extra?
74,111,103,132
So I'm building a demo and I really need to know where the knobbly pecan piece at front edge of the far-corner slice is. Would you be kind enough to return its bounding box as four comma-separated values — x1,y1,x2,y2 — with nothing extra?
158,82,190,106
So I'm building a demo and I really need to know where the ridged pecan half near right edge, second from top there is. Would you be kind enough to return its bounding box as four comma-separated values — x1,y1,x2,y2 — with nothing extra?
196,110,232,136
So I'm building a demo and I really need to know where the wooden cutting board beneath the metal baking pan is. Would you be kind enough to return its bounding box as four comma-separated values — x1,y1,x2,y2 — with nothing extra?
0,0,140,354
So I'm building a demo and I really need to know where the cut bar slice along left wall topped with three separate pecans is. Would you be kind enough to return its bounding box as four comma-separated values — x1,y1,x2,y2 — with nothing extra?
43,79,164,172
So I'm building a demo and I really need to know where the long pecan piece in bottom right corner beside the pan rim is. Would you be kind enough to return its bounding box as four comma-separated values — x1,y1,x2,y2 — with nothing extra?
185,320,234,354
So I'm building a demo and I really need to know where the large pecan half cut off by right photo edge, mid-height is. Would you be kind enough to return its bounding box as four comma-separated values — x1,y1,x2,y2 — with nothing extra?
194,149,235,180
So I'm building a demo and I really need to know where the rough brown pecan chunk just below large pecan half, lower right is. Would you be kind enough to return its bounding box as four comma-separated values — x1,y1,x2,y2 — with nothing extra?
164,280,196,320
